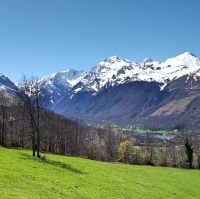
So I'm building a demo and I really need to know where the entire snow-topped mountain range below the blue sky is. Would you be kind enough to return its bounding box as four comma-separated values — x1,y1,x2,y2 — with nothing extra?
0,52,200,129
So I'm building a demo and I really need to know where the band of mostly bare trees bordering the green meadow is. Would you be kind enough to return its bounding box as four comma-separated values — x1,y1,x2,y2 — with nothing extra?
0,76,200,169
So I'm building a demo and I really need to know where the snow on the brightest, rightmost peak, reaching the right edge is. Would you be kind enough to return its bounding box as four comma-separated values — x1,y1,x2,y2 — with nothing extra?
138,52,200,85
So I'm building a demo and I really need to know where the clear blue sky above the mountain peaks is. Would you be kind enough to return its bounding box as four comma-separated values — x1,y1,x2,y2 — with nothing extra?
0,0,200,80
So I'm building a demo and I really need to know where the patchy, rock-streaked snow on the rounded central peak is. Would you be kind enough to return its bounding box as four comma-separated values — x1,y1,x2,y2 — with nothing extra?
74,56,140,92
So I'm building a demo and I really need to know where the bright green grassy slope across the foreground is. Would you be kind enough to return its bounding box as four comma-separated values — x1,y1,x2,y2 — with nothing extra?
0,147,200,199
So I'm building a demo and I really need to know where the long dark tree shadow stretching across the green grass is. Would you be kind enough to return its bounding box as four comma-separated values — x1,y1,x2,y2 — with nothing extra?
20,153,86,174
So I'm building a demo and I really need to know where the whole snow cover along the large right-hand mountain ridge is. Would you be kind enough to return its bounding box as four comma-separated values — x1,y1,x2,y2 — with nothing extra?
74,52,200,93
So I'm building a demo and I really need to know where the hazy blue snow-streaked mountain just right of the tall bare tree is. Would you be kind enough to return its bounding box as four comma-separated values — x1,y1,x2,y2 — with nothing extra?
38,69,87,107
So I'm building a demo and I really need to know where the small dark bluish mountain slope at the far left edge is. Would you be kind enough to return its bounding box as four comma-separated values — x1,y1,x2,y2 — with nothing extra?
0,73,19,95
